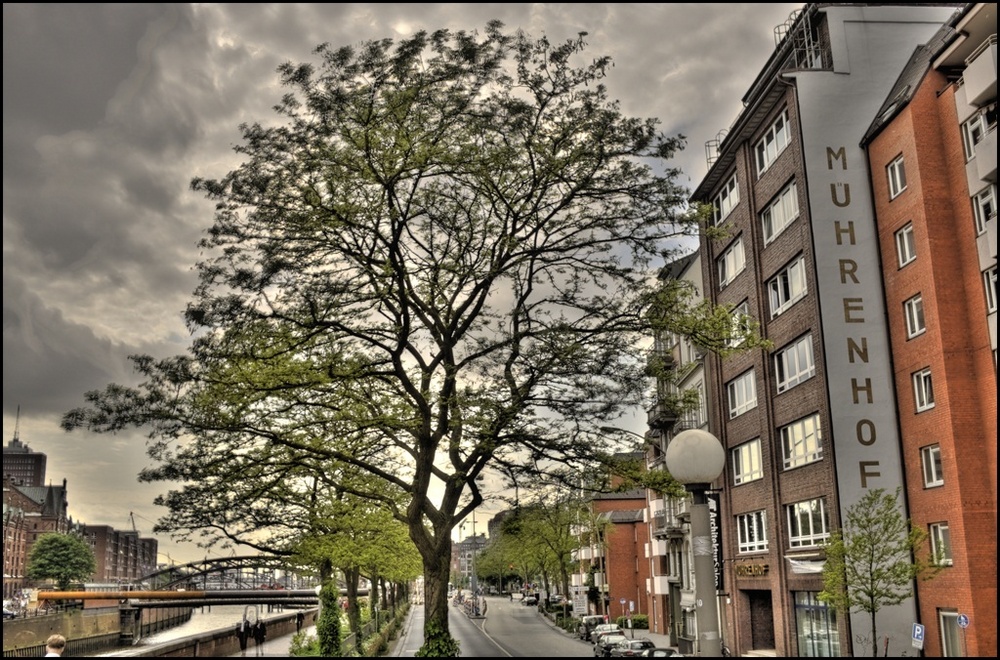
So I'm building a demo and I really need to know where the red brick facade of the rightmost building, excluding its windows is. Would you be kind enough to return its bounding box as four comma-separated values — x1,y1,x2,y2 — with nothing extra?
869,65,997,656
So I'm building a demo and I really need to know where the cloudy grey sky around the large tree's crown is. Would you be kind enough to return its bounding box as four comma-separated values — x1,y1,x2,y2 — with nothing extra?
3,3,802,561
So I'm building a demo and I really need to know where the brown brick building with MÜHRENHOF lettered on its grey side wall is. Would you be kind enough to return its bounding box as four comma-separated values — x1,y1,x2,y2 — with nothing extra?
692,3,959,656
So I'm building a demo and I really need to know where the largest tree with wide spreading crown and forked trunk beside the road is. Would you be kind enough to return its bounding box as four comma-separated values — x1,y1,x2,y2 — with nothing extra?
63,22,752,654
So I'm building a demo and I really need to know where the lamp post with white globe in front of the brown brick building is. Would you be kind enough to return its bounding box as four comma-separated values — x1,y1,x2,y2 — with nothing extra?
664,429,726,657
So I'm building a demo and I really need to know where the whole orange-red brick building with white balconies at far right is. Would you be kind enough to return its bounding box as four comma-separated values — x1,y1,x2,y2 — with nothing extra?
864,4,997,656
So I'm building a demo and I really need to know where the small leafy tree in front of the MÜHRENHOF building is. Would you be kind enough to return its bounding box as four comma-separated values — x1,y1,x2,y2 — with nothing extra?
819,488,940,657
